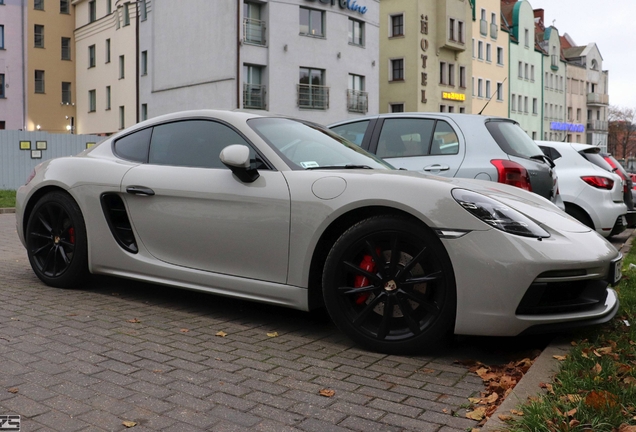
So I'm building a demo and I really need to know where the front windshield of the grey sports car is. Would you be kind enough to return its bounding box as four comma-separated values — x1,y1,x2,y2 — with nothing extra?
248,117,395,170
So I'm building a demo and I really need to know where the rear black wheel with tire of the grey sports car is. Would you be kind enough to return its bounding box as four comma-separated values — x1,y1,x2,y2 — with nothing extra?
25,192,89,288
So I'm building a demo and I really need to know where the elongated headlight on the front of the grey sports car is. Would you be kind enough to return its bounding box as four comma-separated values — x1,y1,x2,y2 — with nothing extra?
451,189,550,238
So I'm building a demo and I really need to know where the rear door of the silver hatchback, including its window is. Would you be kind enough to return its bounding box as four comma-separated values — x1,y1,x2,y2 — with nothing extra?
370,117,465,177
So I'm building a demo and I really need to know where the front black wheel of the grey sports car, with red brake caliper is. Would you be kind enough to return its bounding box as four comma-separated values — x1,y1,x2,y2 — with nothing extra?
323,215,457,354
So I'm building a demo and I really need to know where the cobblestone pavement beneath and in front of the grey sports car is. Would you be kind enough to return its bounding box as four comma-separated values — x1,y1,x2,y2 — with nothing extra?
0,214,483,432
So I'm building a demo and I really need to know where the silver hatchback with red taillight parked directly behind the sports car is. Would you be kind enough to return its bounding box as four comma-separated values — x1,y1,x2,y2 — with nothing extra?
329,112,557,203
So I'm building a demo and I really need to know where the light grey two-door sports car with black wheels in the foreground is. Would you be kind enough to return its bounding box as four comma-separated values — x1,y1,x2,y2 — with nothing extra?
16,110,622,353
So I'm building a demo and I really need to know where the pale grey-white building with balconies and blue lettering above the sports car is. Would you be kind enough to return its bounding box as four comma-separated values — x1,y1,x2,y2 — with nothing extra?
139,0,380,124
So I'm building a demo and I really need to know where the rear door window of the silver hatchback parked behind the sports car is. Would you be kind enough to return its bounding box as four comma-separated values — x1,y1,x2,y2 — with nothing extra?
376,118,435,158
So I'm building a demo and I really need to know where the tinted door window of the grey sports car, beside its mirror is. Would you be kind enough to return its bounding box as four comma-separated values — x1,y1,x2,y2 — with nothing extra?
148,120,263,169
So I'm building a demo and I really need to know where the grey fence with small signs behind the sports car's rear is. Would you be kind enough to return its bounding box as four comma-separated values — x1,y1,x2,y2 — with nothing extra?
0,130,104,190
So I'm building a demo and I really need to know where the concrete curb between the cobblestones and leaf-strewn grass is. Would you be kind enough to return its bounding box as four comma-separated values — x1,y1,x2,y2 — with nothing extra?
479,230,636,432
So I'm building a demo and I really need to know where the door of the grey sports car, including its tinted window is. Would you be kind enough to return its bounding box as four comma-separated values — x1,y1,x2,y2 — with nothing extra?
121,119,290,283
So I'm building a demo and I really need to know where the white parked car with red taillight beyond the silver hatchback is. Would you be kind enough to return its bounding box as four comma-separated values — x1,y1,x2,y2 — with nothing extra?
537,141,627,237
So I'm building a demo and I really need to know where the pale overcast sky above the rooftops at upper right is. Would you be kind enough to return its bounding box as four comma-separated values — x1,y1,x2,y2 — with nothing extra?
528,0,636,109
